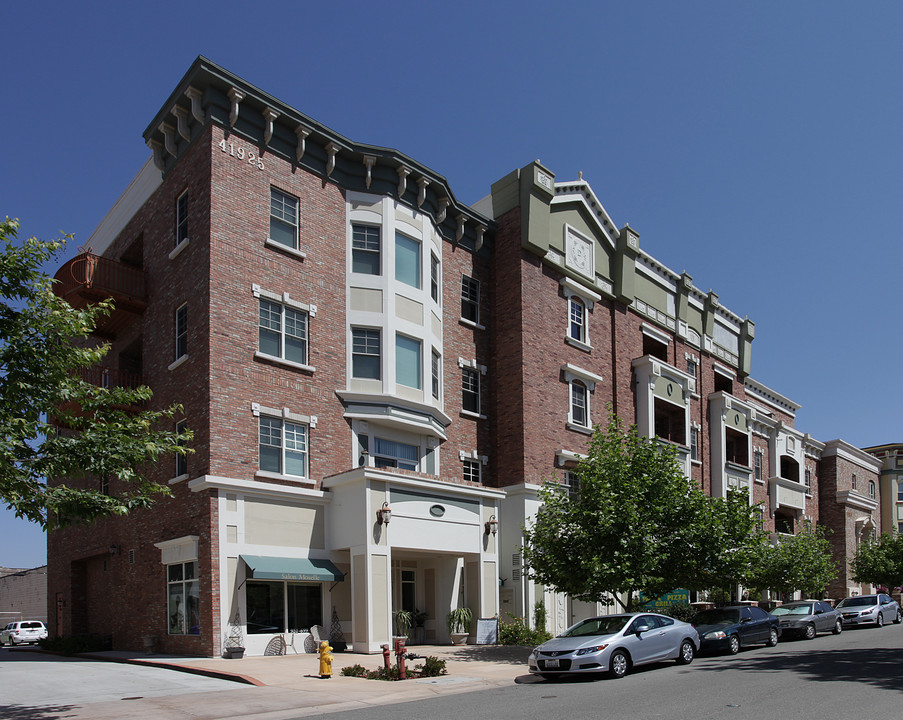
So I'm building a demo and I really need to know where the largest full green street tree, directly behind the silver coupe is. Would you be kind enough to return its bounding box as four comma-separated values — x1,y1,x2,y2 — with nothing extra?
524,415,708,609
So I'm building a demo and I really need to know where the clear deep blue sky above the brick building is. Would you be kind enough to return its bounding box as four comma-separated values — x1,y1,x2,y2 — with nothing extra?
0,0,903,566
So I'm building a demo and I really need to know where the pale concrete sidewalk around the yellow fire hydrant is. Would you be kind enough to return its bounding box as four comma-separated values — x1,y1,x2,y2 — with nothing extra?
67,645,533,720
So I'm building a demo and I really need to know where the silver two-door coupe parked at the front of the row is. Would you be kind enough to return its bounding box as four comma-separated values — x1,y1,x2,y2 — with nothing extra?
527,613,699,678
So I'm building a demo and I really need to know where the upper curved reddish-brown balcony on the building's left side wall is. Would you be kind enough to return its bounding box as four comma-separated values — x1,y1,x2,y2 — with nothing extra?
53,252,147,337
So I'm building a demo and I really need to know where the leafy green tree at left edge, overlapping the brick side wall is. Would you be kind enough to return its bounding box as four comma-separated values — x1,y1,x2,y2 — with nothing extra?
0,218,192,527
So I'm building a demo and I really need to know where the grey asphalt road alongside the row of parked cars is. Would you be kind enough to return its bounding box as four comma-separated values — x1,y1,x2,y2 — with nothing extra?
329,625,903,720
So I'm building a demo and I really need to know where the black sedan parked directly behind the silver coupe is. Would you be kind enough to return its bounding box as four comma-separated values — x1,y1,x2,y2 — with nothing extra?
693,605,781,655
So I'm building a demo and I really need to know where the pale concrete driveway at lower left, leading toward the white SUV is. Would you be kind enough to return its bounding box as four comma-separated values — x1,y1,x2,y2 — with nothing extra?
0,648,250,718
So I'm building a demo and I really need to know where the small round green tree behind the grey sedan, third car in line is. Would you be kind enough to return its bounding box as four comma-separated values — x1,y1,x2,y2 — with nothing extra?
750,521,837,597
